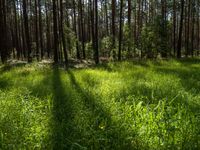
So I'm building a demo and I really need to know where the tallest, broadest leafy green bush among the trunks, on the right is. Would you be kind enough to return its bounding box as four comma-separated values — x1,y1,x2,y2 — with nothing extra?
141,16,170,58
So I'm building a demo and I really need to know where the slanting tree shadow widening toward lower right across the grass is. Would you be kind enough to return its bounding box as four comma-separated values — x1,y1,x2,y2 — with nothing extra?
67,70,148,150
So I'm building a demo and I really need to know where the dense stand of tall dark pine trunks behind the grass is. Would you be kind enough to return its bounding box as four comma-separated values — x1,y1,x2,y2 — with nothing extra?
0,0,200,63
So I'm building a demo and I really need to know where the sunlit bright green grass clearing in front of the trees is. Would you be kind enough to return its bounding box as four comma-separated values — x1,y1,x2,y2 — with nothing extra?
0,59,200,150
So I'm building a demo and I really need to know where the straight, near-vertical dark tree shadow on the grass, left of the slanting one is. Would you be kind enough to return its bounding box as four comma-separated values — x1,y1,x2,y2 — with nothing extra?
52,67,79,150
